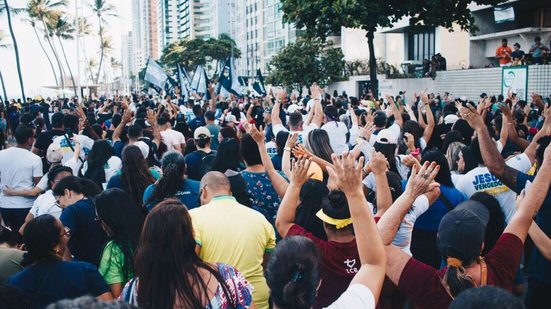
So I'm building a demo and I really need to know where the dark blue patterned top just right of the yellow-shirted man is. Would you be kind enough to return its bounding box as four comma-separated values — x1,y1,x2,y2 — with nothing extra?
241,171,285,225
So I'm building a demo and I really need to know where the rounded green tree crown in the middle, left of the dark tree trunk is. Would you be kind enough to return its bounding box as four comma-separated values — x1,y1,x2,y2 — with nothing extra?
268,38,346,89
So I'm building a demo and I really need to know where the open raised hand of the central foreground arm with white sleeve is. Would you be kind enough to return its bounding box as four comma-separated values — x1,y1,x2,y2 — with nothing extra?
331,152,364,195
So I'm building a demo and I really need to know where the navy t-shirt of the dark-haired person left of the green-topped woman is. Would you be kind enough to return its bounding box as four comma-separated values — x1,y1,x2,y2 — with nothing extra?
59,199,107,265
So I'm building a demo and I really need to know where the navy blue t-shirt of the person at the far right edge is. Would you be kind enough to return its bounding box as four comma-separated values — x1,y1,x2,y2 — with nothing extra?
514,172,551,283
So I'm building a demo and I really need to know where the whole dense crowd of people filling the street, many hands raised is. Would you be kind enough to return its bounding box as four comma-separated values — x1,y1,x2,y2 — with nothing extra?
0,84,551,309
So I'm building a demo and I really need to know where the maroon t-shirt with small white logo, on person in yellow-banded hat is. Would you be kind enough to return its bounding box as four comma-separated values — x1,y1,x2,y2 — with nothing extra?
287,224,361,309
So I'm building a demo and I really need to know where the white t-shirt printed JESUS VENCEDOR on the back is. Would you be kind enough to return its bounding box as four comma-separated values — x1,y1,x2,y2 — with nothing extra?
452,154,532,223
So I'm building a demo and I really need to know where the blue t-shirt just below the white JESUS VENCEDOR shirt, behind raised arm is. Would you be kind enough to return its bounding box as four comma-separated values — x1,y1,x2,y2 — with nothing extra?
413,185,467,232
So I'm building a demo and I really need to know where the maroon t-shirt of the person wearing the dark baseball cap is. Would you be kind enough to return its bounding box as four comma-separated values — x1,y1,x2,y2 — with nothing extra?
398,233,523,309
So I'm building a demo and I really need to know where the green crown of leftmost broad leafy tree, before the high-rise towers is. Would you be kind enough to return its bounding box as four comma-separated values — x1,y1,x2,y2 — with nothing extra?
160,34,241,69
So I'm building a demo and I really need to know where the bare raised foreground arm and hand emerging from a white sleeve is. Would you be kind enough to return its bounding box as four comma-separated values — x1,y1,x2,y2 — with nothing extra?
331,152,387,303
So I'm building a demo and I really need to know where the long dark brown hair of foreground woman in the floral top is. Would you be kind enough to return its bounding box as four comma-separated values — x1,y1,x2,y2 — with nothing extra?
135,199,237,309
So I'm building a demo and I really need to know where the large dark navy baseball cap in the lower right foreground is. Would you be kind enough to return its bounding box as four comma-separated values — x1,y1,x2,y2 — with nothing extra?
438,200,490,260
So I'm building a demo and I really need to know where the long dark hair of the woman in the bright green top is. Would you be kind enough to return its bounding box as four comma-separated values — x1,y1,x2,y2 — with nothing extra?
94,188,145,282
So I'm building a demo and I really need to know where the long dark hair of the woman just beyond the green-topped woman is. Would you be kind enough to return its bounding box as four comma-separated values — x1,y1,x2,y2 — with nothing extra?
120,145,155,207
